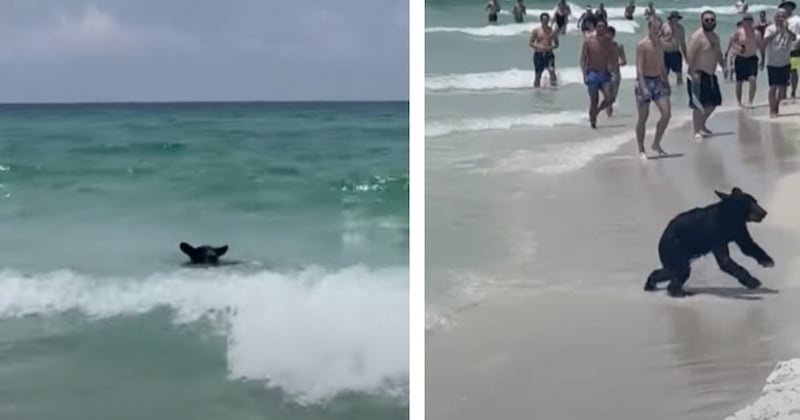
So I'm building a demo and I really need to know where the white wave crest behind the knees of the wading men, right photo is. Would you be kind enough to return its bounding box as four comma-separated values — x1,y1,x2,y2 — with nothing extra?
425,64,636,91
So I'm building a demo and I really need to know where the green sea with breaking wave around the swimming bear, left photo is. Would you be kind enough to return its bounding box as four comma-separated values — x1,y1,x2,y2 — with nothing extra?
0,102,408,420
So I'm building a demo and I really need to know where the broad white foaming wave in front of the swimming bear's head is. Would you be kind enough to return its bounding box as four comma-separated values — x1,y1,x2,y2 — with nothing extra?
0,267,409,403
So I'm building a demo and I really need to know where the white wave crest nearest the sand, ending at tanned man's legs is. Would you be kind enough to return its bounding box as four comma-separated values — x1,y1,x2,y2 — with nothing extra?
425,111,588,137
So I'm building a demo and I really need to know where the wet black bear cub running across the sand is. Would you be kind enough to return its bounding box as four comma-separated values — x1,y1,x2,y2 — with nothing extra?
644,187,775,297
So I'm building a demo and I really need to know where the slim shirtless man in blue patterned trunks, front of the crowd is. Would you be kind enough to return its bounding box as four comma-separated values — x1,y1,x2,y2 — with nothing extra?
634,15,672,159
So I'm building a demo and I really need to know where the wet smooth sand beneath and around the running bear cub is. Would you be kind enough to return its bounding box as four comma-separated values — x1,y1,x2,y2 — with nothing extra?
426,108,800,420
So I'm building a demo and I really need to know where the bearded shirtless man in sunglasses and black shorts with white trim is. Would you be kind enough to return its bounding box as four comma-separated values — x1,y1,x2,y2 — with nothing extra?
686,10,727,140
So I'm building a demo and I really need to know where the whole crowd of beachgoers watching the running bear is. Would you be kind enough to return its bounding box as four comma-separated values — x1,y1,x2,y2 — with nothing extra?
506,0,800,158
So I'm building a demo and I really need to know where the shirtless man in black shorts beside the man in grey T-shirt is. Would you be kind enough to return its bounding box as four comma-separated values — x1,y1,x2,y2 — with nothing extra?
732,14,764,107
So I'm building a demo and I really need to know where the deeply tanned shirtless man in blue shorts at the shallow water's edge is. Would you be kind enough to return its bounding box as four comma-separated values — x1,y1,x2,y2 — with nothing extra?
580,20,619,128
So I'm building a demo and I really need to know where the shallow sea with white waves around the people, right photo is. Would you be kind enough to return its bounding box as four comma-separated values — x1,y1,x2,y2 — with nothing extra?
425,0,773,326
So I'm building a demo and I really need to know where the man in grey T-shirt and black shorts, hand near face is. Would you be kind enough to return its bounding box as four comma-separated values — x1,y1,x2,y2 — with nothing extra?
761,9,797,118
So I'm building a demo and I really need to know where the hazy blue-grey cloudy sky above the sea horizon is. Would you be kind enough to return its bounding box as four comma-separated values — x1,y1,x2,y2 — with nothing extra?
0,0,408,102
